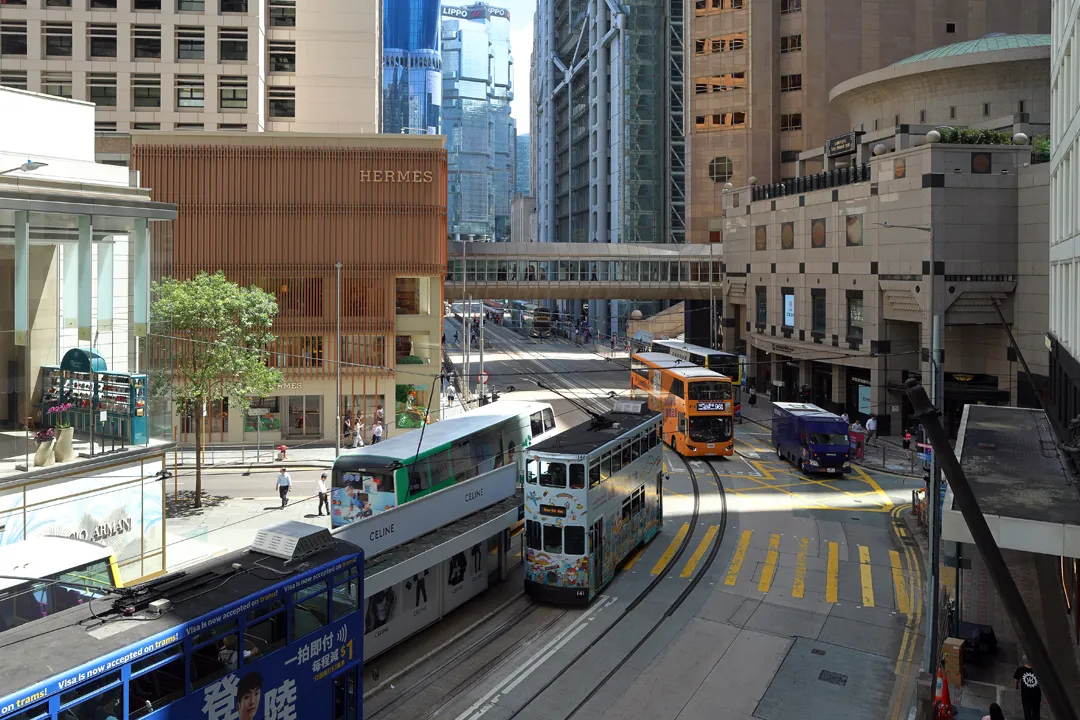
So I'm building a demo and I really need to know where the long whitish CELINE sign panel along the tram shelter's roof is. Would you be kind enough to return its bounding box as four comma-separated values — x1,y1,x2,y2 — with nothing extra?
334,463,517,558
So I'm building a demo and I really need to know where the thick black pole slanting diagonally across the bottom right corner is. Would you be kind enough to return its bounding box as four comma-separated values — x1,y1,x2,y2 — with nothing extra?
905,379,1080,720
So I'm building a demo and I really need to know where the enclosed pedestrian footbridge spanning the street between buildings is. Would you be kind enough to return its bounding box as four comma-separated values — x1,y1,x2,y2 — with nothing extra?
445,242,724,300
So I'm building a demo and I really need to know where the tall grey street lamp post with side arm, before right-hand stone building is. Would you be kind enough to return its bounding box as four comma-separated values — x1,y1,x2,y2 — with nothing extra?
875,220,945,675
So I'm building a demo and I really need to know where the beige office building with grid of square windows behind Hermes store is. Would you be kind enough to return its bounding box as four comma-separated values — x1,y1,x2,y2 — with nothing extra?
0,0,382,133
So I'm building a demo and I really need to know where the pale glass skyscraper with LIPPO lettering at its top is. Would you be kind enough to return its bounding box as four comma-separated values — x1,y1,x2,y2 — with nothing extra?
442,4,517,242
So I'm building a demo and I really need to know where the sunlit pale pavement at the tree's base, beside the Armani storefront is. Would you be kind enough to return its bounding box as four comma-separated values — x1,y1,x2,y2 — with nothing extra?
165,487,334,572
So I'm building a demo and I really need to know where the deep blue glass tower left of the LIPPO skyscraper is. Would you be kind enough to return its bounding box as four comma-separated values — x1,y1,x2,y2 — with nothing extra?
382,0,443,133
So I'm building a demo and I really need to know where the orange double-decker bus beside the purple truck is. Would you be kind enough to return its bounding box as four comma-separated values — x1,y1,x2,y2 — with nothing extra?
630,353,734,458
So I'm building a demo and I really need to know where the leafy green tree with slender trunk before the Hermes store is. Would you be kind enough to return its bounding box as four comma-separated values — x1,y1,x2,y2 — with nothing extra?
150,272,281,507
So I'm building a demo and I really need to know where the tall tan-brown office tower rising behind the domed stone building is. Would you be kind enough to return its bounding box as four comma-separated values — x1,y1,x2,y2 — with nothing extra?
686,0,1050,243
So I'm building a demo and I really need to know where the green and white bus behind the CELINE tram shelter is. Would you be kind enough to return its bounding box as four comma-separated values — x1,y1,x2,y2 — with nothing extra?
330,400,555,528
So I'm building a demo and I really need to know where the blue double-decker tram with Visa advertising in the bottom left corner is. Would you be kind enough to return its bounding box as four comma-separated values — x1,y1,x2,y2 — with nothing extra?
0,522,364,720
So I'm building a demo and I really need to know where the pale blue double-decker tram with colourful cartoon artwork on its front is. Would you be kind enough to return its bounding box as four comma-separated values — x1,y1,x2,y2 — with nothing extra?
525,400,663,604
